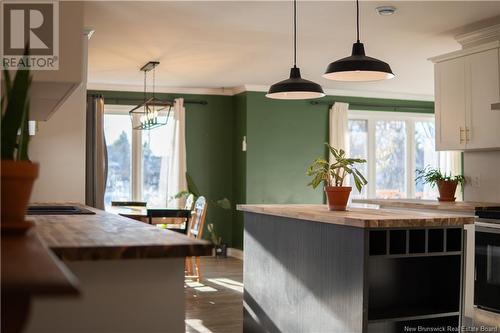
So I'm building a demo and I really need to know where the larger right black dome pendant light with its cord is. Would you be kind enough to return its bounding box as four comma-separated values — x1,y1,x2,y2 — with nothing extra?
323,0,394,81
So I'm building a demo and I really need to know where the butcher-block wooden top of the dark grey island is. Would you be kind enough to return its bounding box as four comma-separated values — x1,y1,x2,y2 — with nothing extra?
237,205,474,228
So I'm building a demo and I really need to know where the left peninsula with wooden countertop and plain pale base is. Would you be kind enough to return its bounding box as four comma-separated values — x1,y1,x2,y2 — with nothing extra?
26,207,212,333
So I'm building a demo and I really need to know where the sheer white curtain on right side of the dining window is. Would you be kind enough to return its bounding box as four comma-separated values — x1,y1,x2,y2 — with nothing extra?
160,98,187,208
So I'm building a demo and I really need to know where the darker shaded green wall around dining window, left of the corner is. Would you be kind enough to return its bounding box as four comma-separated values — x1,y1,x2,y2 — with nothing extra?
88,91,235,246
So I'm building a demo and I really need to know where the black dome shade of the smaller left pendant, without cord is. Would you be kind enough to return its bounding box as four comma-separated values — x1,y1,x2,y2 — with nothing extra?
266,67,325,99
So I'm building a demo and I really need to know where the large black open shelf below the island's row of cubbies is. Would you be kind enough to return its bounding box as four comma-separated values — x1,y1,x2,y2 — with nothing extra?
368,256,461,320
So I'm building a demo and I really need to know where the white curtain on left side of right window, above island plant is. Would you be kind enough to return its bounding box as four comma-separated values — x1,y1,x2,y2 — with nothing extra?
329,102,349,161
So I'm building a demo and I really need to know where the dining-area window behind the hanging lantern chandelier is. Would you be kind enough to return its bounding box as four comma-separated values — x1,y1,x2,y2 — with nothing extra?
104,104,173,207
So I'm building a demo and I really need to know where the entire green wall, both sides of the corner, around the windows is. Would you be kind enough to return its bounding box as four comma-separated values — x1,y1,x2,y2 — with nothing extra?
89,91,434,249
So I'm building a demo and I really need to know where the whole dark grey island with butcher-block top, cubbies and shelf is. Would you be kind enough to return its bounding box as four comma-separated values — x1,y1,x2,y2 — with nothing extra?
238,205,474,333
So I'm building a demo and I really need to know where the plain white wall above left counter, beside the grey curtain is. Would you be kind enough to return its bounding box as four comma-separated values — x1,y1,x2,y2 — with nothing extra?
29,33,88,204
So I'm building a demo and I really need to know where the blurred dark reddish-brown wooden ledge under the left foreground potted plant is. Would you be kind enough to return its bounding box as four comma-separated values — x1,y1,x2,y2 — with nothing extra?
2,230,79,296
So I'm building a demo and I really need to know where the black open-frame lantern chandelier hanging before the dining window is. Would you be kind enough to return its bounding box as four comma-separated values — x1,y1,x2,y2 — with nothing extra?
129,61,173,130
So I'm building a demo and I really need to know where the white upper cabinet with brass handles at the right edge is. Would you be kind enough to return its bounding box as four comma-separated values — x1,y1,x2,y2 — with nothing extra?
430,42,500,150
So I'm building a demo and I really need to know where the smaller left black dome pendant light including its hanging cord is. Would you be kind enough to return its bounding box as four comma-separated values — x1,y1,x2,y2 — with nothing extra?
266,0,325,99
